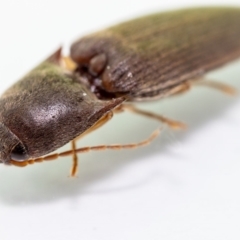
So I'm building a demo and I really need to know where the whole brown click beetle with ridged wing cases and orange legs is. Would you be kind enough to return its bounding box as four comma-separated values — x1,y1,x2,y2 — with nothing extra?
0,7,240,176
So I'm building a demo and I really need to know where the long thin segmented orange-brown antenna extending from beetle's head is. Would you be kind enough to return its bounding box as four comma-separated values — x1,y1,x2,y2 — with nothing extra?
10,128,160,167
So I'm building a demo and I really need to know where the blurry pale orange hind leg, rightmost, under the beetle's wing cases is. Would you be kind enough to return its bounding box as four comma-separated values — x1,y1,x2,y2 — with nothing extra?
191,79,237,95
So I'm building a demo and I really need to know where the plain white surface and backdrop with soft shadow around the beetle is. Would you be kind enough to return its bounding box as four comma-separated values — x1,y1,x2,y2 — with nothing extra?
0,0,240,240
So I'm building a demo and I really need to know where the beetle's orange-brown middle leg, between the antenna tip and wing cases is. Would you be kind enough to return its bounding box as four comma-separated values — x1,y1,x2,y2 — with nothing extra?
123,105,186,129
